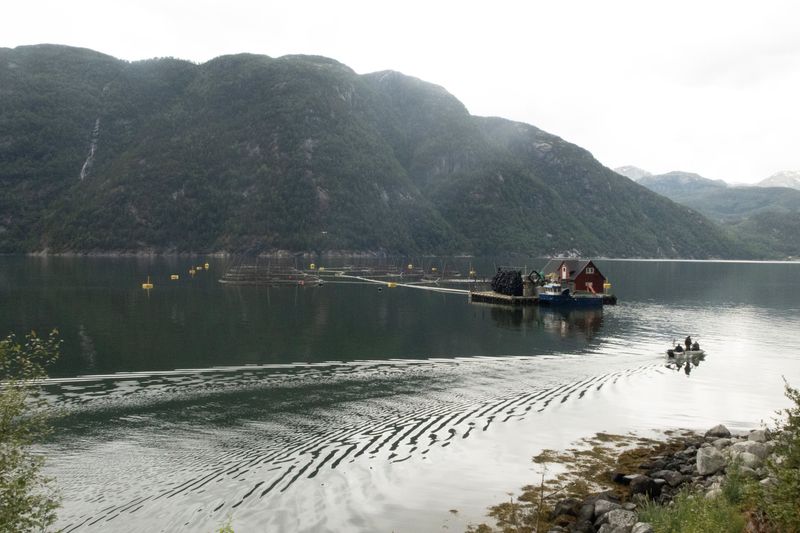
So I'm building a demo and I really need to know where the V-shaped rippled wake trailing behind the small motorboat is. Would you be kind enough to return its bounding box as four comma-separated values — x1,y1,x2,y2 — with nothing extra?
47,356,662,531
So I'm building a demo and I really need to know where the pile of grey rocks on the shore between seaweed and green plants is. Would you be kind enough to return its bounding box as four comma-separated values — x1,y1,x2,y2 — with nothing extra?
548,425,776,533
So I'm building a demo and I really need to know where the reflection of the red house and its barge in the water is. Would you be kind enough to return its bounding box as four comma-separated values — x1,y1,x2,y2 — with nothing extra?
491,305,603,338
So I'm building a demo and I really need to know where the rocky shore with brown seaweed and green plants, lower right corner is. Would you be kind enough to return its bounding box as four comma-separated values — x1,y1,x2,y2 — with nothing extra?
467,383,800,533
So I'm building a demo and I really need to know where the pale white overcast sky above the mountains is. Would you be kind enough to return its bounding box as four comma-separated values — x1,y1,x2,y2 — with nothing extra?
0,0,800,183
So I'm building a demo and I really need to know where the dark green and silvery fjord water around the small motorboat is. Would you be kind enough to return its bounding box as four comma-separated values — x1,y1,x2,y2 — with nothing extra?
0,257,800,531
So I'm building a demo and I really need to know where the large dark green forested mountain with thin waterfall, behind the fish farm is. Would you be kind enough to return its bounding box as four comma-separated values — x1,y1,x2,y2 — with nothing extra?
0,45,753,257
